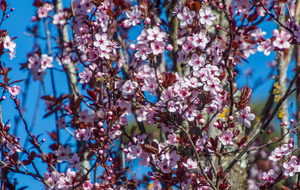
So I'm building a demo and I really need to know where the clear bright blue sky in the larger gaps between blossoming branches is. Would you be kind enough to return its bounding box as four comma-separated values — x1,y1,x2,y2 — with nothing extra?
1,0,295,189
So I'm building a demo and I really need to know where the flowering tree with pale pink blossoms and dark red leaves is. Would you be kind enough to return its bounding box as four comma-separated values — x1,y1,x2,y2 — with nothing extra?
0,0,300,190
